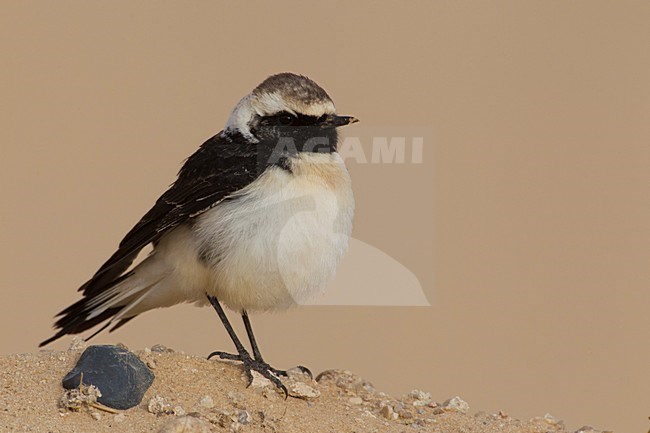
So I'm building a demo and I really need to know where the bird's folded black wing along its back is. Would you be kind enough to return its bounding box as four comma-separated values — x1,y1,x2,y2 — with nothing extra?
77,133,259,298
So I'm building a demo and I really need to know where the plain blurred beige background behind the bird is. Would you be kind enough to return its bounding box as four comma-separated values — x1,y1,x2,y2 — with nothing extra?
0,1,650,432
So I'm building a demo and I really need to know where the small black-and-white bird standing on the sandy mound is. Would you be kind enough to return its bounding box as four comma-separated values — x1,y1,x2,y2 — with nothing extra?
39,72,358,398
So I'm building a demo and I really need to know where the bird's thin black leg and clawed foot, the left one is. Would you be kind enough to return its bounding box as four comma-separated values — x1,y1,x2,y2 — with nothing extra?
207,295,289,398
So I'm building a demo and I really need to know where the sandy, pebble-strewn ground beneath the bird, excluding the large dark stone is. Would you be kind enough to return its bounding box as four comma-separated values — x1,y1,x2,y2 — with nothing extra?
0,346,596,433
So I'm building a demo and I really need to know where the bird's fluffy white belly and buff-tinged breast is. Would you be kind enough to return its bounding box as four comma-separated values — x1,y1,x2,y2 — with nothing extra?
193,154,354,310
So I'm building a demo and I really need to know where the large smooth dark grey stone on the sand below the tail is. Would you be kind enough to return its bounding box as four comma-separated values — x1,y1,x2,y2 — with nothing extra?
63,346,154,409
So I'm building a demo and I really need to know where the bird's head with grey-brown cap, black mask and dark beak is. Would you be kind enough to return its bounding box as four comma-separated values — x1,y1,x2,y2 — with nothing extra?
225,72,357,152
